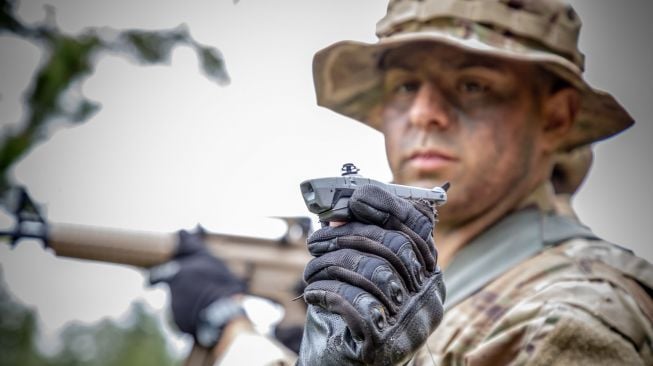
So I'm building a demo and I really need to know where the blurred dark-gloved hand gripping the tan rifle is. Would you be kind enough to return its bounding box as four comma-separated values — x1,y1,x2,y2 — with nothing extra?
150,230,247,346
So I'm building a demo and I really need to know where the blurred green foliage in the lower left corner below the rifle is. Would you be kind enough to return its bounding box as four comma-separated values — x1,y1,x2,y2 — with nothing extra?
0,273,181,366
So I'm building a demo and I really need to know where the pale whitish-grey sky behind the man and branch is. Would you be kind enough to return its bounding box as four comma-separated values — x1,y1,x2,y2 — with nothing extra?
0,0,653,358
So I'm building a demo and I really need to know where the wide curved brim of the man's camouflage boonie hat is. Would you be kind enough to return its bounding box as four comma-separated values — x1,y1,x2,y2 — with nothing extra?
313,31,634,150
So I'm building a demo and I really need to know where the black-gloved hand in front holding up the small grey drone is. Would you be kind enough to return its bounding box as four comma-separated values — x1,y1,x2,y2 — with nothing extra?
298,185,445,365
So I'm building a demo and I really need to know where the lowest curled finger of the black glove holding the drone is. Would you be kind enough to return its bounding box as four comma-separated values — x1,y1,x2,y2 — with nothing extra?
304,280,388,344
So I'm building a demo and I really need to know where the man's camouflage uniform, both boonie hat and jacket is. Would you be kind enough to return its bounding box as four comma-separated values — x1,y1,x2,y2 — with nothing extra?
219,0,653,366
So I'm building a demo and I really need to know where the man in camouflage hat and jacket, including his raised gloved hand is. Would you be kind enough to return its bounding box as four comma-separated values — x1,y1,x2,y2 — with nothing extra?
159,0,653,365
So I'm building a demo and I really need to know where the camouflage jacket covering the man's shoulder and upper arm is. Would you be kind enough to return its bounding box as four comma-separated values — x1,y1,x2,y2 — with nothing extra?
411,186,653,366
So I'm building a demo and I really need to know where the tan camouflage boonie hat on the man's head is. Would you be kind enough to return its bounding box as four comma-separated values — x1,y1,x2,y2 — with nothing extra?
313,0,634,150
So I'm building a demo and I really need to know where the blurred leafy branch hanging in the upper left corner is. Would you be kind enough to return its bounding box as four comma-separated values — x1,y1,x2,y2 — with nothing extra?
0,0,229,196
